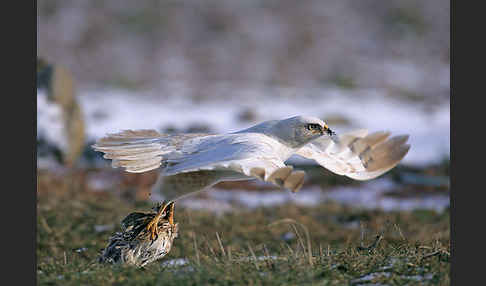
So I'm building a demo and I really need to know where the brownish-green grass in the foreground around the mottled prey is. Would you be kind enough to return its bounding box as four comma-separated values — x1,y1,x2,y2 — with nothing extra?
37,169,450,285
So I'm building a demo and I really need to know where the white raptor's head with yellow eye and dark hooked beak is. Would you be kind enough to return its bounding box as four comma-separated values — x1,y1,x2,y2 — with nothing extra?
275,116,336,147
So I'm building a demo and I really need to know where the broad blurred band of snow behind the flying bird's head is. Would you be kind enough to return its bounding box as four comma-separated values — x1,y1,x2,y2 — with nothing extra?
74,84,450,165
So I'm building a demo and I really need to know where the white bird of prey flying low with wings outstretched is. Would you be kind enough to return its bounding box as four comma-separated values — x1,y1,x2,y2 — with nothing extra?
93,116,410,237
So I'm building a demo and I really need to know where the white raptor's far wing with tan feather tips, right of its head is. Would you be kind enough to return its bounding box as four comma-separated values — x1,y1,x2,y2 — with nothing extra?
296,130,410,180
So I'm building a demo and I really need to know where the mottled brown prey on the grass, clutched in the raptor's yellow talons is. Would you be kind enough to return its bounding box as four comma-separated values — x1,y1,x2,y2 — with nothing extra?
98,201,178,267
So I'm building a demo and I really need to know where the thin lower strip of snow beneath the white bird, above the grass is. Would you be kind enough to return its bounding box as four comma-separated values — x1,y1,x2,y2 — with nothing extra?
170,178,450,214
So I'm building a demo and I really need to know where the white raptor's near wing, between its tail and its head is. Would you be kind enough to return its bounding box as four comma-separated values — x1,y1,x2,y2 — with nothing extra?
164,133,305,192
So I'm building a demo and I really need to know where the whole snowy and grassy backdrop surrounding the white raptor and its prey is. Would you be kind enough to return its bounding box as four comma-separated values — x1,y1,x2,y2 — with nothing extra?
36,0,450,285
